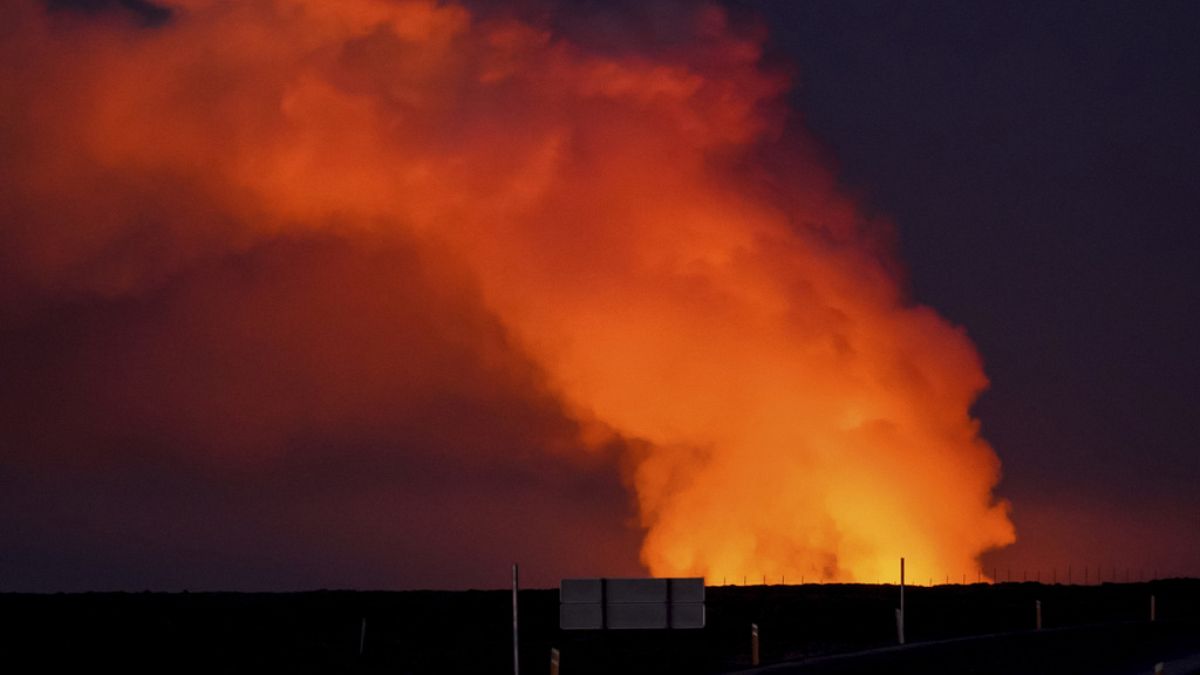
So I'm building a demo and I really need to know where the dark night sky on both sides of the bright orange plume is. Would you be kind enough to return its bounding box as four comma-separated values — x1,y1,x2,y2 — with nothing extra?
0,0,1200,591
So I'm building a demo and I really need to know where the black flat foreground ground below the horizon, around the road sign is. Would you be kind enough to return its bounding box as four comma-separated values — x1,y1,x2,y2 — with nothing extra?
0,580,1200,675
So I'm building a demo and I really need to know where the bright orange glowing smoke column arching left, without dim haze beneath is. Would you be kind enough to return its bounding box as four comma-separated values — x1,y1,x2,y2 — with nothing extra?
0,0,1014,581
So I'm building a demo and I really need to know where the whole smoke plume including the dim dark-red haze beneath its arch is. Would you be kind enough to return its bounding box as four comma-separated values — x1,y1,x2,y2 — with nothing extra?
0,0,1014,585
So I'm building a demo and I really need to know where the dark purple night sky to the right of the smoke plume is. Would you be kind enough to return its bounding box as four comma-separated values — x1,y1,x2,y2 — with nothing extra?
755,2,1200,574
